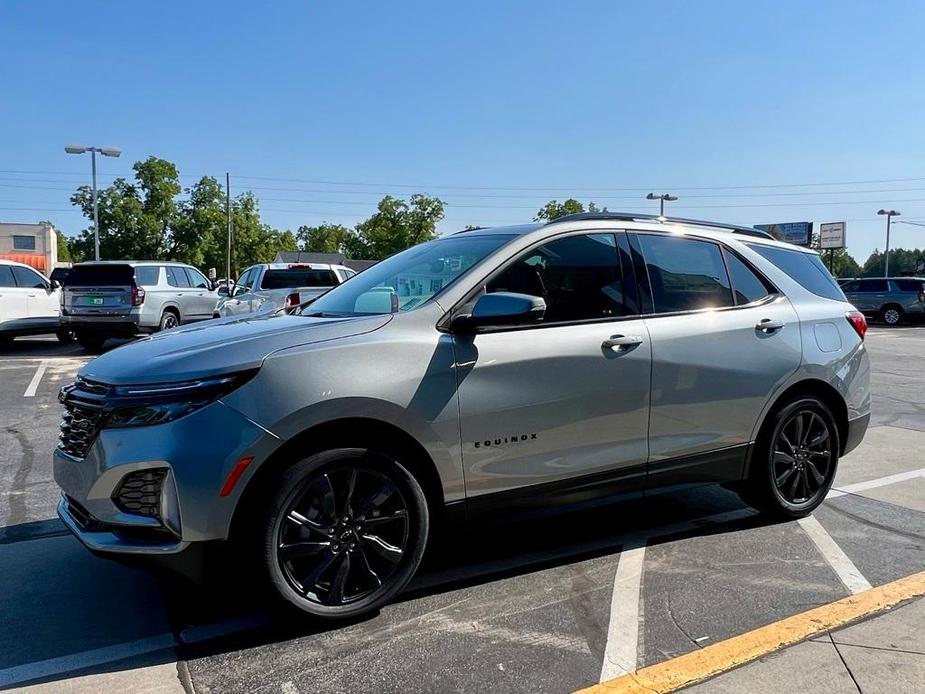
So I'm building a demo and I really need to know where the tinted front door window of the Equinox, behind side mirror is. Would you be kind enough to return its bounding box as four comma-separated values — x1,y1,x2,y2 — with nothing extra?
488,234,629,323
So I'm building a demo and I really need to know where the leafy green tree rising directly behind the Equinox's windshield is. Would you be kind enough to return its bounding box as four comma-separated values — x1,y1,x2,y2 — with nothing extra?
349,193,443,260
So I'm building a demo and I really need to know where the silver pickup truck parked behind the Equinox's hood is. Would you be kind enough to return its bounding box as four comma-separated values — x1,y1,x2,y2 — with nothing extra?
214,263,356,318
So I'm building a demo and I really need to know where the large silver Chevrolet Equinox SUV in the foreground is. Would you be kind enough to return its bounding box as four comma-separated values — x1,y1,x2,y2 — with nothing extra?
54,213,870,617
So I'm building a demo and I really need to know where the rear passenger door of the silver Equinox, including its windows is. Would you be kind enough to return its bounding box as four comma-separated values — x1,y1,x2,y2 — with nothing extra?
631,232,801,486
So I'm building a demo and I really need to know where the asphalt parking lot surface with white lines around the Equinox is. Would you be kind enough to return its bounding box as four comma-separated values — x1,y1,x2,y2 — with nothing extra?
0,327,925,694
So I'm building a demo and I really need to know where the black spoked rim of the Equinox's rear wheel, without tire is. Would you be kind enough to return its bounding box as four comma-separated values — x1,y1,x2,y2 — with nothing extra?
772,410,833,504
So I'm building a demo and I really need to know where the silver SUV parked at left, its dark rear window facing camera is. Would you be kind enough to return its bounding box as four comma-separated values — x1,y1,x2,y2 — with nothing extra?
61,260,219,352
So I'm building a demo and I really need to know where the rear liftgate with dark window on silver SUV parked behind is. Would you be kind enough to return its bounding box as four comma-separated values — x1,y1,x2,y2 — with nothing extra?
62,263,135,317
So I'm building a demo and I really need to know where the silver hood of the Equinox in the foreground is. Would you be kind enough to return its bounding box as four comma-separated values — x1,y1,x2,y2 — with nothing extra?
79,314,392,385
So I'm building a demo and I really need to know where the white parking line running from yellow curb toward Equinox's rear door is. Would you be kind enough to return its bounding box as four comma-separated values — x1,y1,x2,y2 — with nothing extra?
598,539,646,682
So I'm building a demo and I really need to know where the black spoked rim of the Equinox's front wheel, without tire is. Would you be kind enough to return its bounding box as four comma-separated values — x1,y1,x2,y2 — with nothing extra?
277,468,409,606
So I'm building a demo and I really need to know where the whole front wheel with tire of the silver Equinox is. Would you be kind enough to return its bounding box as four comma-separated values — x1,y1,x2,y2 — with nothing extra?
259,448,430,619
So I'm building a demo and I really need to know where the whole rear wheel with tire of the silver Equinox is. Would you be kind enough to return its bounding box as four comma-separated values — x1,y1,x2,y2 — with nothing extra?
736,395,841,519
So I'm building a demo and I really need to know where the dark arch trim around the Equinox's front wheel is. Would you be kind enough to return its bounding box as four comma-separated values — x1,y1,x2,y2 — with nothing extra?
229,417,445,539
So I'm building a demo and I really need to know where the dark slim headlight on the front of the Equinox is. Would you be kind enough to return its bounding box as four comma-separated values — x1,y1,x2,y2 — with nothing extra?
104,371,256,428
